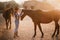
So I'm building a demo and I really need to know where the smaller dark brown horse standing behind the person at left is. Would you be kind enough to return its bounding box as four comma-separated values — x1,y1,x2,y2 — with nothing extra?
3,8,13,29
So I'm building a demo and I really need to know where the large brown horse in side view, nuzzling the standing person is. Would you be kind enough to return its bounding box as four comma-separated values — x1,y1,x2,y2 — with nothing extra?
21,9,60,38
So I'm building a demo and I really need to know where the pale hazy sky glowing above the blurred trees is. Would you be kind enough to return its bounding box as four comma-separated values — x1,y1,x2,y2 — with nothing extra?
0,0,60,10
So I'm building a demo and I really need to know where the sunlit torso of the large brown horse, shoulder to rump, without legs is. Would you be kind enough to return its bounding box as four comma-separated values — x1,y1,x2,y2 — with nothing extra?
33,11,60,23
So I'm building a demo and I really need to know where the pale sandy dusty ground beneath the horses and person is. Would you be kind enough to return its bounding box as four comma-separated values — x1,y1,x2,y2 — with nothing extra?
0,15,60,40
